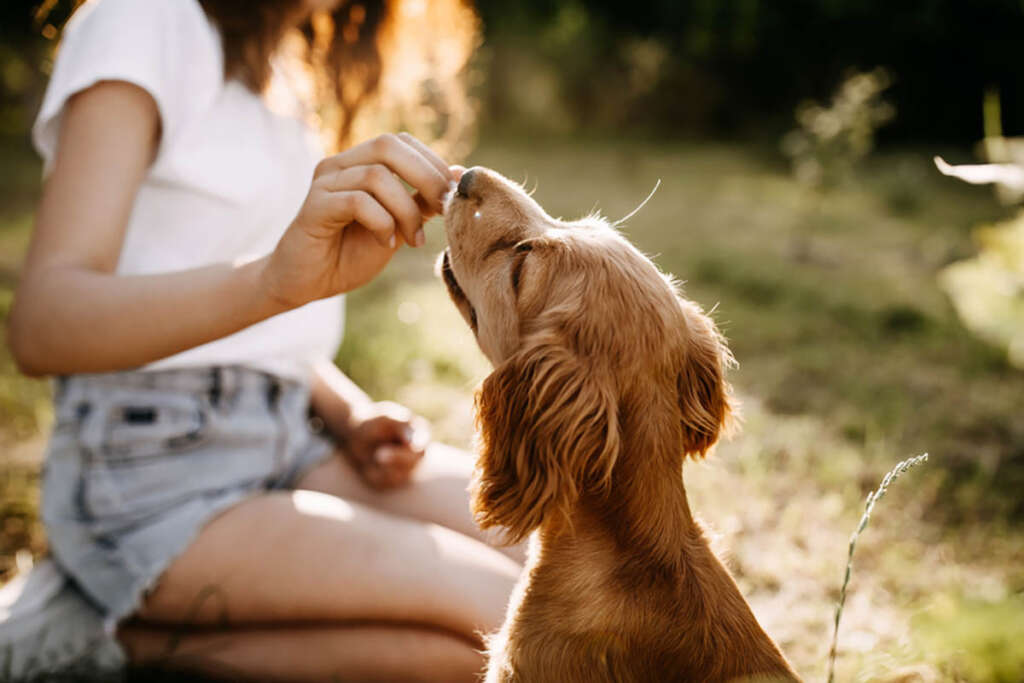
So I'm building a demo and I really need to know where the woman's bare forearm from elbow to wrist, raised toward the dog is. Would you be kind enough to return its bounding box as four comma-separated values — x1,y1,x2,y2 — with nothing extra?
8,259,287,375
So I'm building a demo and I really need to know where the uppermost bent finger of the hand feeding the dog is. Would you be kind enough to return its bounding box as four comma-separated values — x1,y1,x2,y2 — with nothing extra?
316,135,452,211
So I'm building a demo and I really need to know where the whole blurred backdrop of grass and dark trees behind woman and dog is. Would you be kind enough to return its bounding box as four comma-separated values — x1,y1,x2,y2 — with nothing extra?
0,0,1024,682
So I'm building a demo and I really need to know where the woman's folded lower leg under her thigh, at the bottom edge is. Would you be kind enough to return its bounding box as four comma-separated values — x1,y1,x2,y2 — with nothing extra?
121,625,484,683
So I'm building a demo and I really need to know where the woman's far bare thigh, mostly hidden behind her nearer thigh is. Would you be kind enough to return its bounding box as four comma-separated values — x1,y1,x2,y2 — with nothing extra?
296,443,525,563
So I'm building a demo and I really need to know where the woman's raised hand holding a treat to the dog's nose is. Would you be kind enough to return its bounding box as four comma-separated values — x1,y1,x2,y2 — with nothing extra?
261,133,454,308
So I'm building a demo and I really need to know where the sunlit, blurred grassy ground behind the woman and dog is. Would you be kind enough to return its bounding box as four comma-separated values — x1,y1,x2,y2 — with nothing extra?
0,139,1024,682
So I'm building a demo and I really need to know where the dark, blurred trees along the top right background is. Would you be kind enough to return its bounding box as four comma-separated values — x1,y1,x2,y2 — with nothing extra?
477,0,1024,142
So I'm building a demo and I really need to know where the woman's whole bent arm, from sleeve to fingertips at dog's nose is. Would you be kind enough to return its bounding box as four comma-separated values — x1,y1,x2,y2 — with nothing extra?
8,82,451,375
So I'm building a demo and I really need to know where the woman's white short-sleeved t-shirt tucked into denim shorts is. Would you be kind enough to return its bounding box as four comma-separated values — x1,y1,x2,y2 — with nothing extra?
32,0,343,380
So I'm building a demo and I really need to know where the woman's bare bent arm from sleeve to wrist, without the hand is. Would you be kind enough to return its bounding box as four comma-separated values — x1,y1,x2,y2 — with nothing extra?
9,81,284,375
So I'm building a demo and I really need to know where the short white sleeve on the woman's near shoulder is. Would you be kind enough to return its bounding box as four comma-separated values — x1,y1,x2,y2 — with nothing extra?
32,0,223,170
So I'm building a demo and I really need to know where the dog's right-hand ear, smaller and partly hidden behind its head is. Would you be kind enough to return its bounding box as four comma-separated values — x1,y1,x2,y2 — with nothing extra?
676,300,733,458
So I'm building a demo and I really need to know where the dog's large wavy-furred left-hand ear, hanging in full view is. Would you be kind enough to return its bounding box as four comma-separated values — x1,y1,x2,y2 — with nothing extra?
473,343,618,543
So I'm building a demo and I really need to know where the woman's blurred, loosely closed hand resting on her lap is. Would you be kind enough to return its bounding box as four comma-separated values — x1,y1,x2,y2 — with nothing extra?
337,401,430,488
